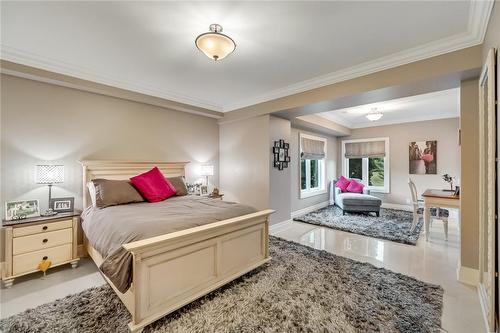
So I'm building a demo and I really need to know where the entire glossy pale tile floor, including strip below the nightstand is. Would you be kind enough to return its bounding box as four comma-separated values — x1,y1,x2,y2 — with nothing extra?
0,211,485,333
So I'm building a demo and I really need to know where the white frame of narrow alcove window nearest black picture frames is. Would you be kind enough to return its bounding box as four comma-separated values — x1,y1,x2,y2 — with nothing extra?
299,133,328,199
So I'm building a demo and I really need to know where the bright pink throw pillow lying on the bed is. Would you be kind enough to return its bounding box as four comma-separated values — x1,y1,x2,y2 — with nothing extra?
130,167,177,202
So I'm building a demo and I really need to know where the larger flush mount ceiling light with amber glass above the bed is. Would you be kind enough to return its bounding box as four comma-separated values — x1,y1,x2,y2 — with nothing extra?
195,23,236,61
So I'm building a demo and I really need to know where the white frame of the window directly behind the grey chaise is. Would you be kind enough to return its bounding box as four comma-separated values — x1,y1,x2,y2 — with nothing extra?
341,137,391,193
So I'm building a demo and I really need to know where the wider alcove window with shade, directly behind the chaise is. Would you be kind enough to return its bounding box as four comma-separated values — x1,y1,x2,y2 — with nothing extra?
342,138,390,193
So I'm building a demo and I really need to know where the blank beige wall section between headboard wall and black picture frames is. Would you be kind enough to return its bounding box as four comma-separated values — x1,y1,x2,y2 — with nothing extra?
219,115,271,209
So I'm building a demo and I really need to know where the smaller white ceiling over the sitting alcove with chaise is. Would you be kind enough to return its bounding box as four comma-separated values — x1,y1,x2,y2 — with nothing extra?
318,88,460,128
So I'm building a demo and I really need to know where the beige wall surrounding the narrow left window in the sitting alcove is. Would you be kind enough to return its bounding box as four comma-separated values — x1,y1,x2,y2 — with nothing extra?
290,128,338,212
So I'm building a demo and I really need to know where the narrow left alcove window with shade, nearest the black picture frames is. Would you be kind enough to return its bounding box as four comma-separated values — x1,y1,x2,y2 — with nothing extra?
300,133,326,198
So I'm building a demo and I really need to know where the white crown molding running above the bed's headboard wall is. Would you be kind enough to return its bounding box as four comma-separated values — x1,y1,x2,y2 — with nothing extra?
0,44,222,112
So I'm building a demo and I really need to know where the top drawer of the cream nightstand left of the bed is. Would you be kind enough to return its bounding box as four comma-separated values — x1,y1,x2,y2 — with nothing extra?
12,225,73,255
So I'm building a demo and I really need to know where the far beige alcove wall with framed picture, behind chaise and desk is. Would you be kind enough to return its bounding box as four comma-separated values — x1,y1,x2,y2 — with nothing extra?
338,118,460,205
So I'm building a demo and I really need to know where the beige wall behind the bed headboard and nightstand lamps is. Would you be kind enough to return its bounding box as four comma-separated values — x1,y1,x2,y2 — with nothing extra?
1,75,219,214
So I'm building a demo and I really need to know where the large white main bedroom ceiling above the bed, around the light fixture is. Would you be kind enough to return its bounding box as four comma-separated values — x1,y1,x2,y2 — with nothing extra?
1,1,492,111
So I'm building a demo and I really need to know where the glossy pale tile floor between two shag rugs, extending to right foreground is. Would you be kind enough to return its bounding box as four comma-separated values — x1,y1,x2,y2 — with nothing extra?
271,214,485,333
